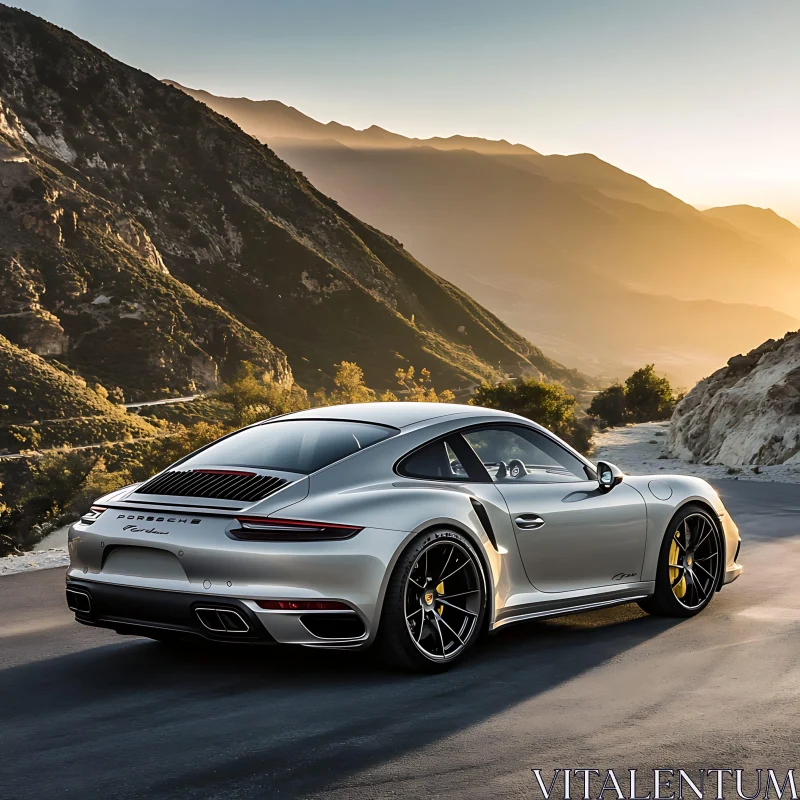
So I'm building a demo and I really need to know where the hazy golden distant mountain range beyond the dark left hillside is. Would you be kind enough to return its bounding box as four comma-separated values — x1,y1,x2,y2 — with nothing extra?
169,87,800,383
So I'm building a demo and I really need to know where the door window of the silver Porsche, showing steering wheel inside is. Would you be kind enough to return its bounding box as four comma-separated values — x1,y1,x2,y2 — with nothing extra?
462,425,589,483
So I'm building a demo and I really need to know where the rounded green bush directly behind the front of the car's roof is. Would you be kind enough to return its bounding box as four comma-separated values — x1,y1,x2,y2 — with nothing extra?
469,378,589,452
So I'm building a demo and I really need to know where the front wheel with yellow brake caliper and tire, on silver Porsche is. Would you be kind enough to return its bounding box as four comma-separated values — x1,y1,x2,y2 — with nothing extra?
639,504,725,618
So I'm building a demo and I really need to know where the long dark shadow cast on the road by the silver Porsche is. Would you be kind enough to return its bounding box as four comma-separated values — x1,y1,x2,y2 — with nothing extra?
0,605,678,798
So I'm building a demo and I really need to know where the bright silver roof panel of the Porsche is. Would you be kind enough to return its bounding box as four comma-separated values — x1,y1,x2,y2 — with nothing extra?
282,402,520,428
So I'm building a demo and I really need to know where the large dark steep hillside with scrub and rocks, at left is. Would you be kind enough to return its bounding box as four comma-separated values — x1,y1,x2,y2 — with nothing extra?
0,6,585,432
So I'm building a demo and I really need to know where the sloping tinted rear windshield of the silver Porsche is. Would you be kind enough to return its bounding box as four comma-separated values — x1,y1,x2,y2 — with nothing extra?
181,419,397,475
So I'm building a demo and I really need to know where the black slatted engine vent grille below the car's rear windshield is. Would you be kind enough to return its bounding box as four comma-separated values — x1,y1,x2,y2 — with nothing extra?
136,469,289,502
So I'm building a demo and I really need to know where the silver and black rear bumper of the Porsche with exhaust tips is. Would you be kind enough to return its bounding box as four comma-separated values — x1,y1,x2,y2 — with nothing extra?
67,518,410,648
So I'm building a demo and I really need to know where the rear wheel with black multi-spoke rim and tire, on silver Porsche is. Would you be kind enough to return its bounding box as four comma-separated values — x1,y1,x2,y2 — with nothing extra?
377,529,486,673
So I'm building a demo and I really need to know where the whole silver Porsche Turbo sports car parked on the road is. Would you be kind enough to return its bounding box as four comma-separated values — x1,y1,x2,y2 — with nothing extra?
66,403,742,671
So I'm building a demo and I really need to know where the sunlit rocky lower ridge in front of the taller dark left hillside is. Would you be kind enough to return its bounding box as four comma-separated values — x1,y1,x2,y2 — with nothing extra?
0,100,293,398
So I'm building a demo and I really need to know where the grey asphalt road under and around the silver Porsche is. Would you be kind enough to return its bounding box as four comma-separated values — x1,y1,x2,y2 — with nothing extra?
0,481,800,800
